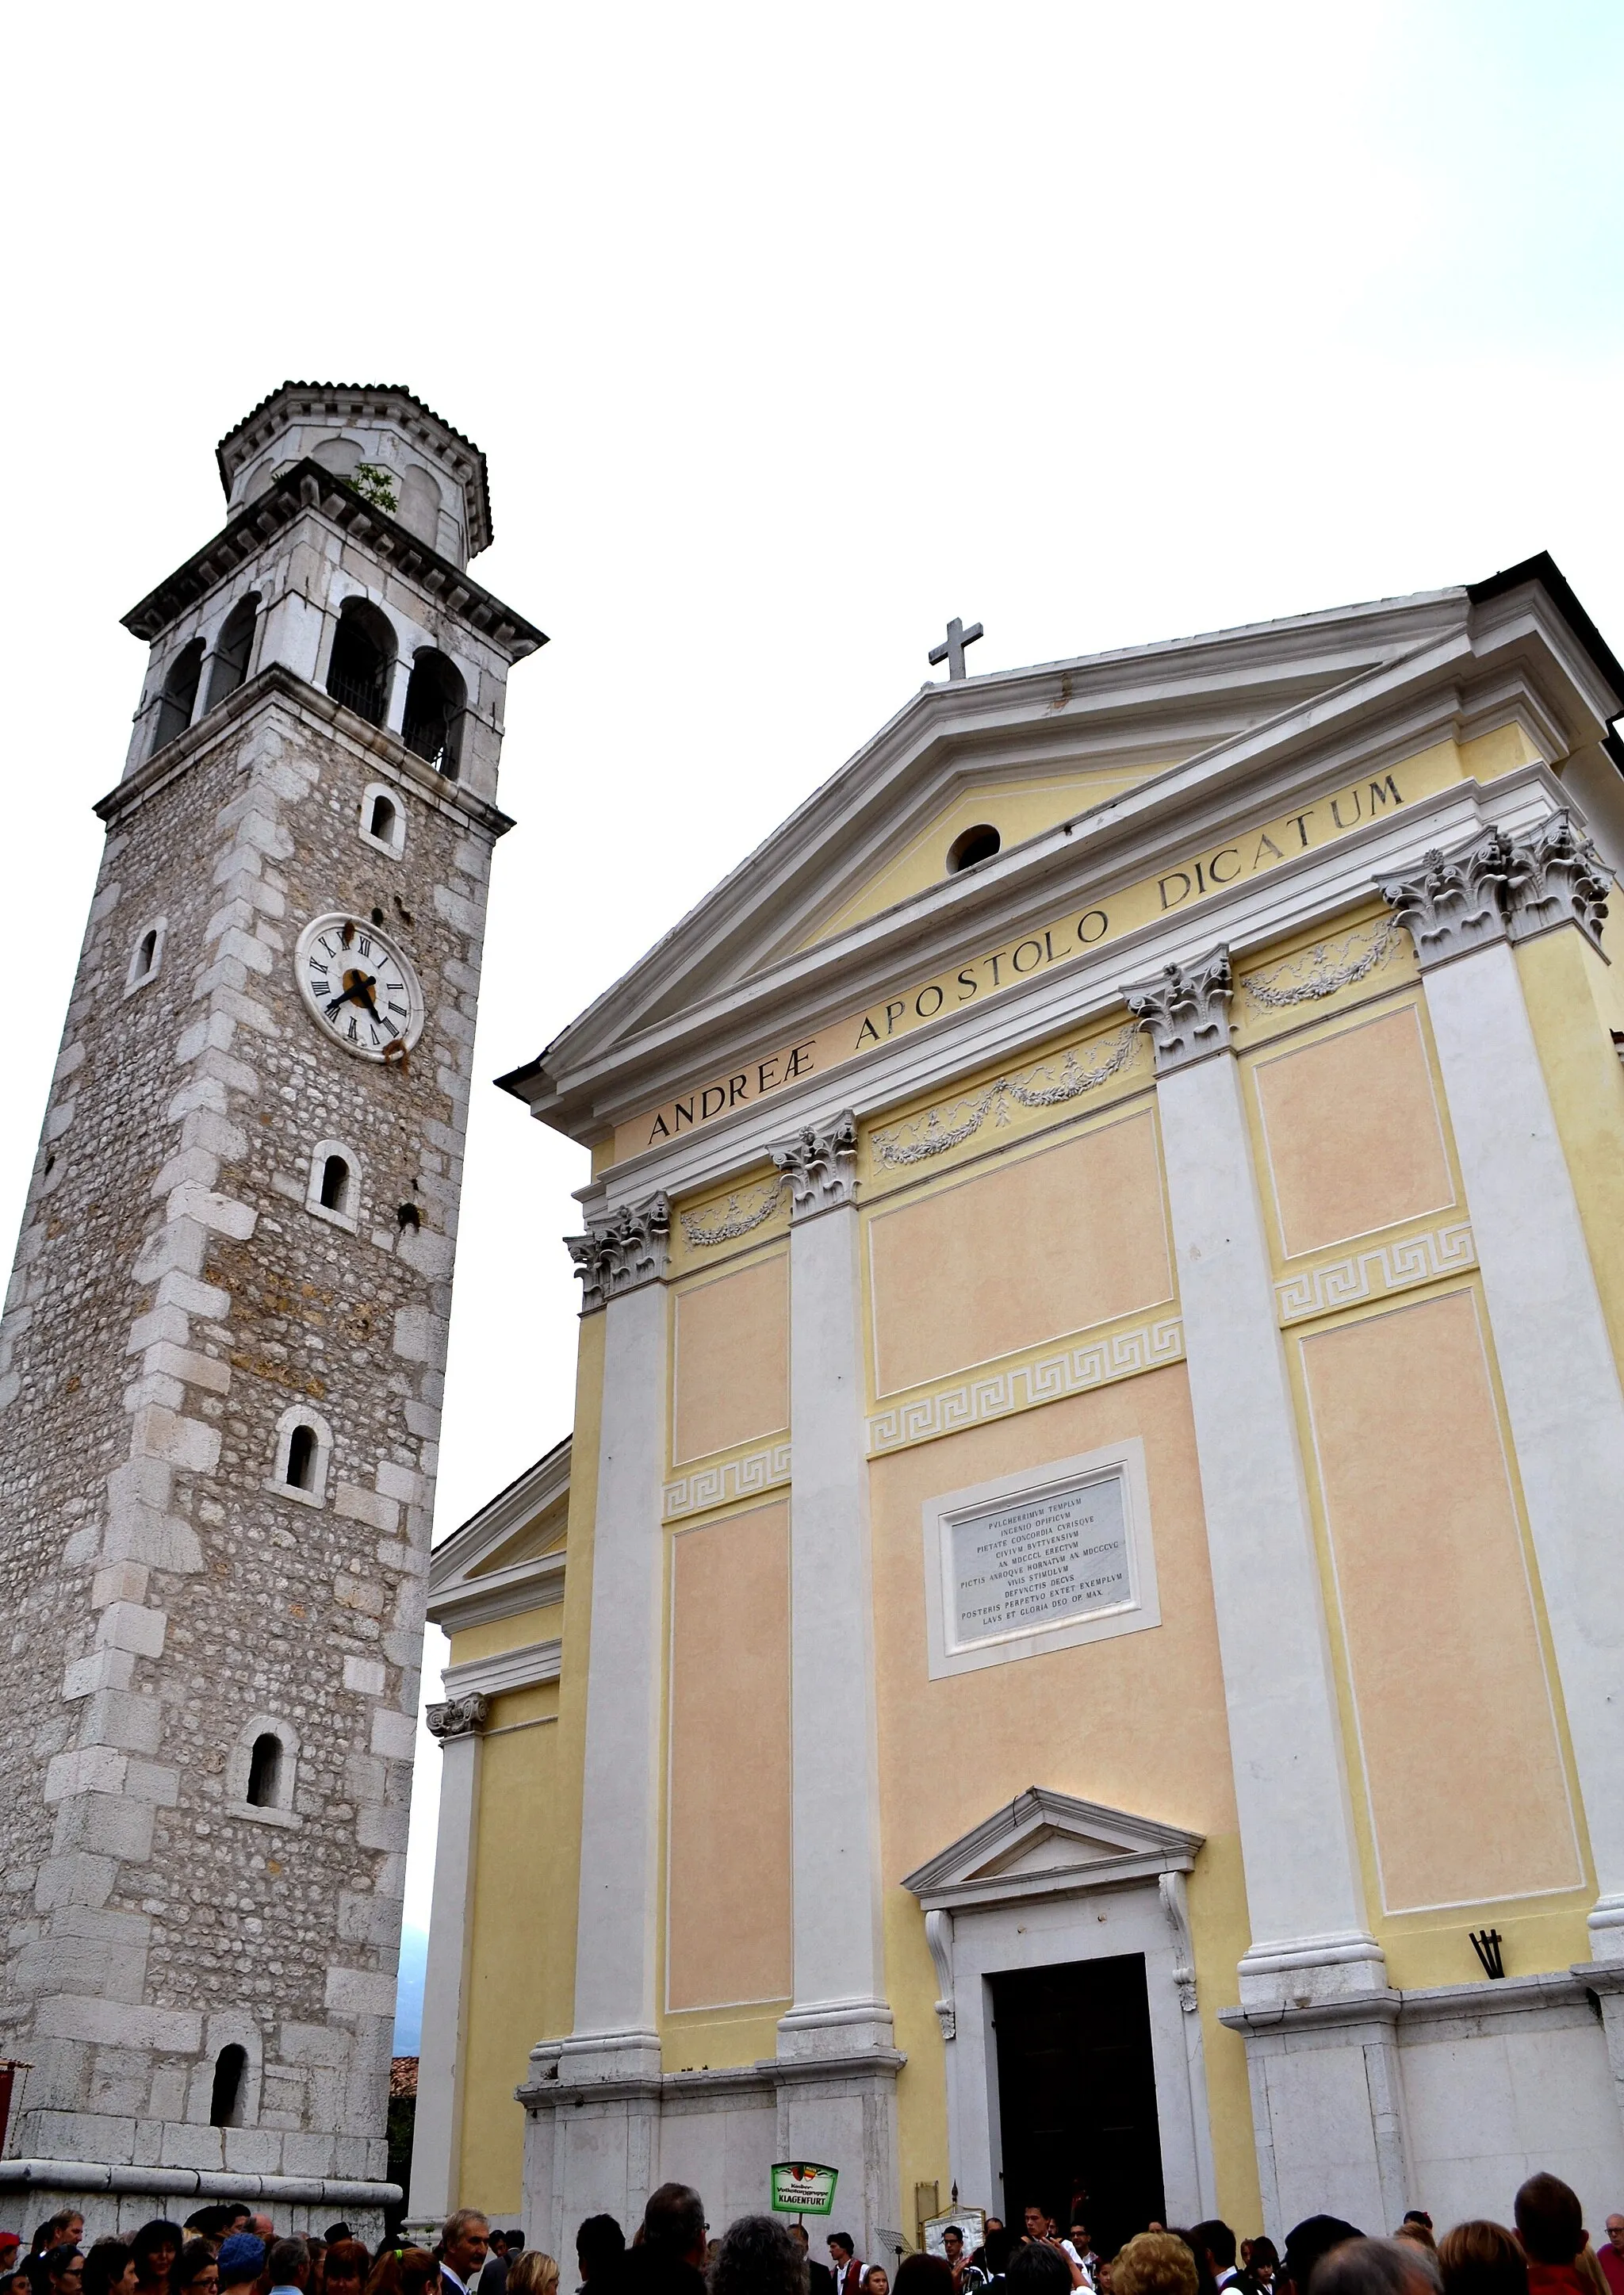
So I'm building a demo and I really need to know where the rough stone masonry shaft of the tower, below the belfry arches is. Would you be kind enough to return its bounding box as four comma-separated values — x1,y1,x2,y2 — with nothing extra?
0,684,491,2178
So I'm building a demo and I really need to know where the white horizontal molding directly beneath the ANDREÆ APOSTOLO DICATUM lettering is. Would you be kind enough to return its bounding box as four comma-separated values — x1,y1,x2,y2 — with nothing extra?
578,764,1576,1214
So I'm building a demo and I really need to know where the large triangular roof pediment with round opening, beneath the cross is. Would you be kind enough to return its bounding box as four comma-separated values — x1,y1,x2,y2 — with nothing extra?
500,560,1624,1161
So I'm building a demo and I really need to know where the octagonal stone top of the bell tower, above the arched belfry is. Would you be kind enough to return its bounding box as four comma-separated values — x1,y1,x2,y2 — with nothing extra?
216,383,491,565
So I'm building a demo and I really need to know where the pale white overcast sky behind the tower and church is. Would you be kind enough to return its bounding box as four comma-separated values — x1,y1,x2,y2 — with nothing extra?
0,0,1624,2001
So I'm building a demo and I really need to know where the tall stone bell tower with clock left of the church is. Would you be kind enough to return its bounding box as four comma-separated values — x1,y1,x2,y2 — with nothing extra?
0,383,546,2231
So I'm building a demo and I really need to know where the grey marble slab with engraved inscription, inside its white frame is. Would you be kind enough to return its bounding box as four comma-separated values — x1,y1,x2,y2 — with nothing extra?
950,1473,1133,1650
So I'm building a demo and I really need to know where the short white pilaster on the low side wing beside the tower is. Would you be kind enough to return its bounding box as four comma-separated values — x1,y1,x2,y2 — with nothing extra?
408,1699,486,2224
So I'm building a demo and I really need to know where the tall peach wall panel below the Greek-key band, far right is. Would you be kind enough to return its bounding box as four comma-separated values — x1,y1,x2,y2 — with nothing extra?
1303,1292,1583,1912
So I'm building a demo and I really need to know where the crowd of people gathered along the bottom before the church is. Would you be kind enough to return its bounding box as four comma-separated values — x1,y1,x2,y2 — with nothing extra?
0,2176,1624,2295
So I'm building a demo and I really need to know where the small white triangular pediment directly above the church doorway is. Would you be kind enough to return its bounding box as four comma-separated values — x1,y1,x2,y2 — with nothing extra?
902,1786,1205,1910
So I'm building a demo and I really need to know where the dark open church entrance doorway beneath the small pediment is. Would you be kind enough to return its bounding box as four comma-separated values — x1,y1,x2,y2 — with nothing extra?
986,1953,1167,2256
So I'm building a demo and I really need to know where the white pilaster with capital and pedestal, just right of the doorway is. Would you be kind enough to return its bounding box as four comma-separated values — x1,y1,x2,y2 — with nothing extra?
1124,948,1406,2238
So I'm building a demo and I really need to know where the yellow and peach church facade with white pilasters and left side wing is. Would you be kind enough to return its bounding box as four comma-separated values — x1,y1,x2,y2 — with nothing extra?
411,560,1624,2254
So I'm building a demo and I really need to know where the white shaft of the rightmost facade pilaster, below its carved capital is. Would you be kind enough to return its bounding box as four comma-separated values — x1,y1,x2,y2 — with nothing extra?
1418,893,1624,1960
